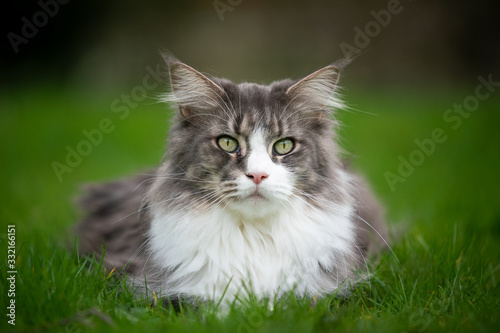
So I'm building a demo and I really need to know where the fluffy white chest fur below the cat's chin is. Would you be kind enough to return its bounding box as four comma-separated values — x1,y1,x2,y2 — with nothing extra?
149,199,354,300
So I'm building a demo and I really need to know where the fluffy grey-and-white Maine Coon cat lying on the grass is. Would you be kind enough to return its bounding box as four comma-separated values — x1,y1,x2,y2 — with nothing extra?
77,57,387,301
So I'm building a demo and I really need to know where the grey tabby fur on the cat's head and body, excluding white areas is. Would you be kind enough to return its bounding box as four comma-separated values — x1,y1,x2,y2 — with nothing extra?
77,58,387,300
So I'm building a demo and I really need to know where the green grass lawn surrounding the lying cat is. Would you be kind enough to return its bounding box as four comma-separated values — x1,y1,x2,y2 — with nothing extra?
0,85,500,332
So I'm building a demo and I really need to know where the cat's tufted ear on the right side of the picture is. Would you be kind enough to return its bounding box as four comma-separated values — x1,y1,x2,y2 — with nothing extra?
286,65,344,117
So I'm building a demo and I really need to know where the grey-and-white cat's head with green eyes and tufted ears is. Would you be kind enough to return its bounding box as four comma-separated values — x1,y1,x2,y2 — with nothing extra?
157,58,348,219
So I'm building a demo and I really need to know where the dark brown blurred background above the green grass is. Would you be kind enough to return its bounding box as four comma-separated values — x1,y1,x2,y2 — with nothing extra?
0,0,500,93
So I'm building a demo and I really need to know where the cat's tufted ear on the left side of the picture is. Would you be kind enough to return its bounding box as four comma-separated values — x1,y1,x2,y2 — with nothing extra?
164,58,224,118
